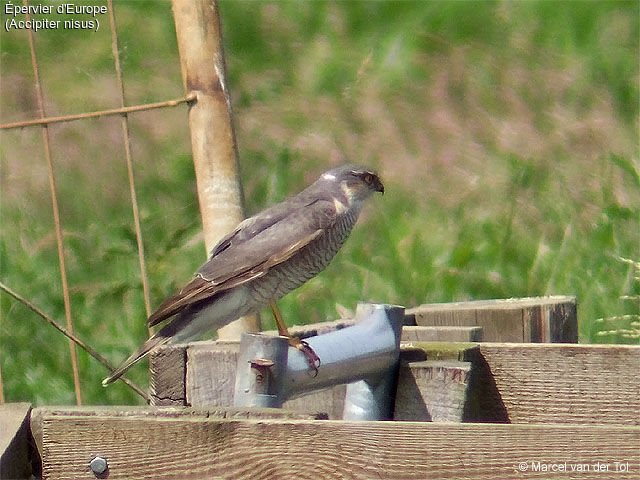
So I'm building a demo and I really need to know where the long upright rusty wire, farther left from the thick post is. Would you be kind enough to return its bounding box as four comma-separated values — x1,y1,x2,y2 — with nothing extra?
22,0,82,405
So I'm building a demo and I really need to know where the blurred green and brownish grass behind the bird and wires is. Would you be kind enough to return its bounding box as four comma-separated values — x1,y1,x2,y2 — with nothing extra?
0,1,640,404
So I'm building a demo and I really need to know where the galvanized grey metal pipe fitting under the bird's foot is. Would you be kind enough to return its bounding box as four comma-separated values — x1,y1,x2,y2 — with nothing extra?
234,303,404,419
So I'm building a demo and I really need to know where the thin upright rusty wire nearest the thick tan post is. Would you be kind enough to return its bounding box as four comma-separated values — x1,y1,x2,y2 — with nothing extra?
107,0,151,324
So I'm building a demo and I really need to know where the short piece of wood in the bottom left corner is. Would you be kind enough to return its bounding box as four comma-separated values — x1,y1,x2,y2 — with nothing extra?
0,403,32,479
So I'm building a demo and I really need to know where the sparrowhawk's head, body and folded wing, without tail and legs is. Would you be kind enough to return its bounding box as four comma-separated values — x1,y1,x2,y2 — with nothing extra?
148,165,384,325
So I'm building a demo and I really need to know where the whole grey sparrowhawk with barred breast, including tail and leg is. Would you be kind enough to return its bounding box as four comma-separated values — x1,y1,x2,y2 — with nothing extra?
102,165,384,386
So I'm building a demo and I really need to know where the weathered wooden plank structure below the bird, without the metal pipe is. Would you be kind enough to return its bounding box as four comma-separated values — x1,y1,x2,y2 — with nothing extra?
5,297,640,479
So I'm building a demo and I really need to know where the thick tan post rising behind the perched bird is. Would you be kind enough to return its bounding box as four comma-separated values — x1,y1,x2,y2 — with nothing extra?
172,0,259,339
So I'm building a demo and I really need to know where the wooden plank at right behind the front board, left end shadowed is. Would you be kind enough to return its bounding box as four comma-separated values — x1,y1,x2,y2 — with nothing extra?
466,344,640,425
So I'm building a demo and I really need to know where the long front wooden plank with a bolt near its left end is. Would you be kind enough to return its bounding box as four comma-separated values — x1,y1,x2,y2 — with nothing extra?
43,415,640,480
